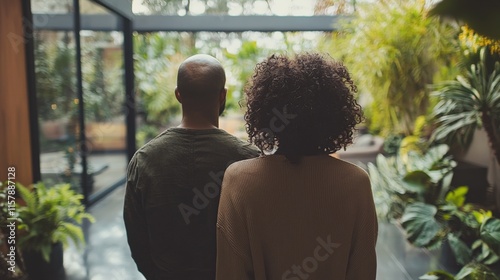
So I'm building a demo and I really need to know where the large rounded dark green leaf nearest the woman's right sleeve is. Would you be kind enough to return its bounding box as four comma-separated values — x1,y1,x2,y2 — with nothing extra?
401,202,441,247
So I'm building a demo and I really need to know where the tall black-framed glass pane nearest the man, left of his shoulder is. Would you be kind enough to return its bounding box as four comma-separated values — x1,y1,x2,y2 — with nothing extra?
80,0,128,195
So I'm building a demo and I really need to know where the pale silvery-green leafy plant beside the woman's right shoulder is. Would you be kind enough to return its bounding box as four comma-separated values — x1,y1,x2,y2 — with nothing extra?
368,144,456,220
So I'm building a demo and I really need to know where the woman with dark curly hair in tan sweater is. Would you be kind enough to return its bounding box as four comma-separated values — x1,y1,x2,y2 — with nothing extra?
216,53,377,280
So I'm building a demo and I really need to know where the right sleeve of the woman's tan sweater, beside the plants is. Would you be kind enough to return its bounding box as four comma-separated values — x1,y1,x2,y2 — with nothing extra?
346,175,378,280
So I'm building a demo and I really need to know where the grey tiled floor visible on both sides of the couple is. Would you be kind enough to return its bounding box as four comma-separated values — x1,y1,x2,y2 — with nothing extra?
64,187,458,280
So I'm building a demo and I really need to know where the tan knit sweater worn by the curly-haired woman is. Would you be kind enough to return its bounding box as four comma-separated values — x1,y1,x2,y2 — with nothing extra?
216,155,377,280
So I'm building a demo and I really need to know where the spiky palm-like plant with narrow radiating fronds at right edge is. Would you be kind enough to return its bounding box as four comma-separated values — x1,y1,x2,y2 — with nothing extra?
433,48,500,163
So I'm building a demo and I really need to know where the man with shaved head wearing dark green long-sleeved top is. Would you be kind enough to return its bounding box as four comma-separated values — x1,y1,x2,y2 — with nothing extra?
123,54,258,280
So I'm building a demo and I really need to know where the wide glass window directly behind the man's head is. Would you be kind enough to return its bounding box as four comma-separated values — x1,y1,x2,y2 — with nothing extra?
134,32,330,144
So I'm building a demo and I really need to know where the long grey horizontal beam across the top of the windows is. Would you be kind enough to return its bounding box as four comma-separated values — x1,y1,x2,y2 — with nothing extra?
33,14,341,32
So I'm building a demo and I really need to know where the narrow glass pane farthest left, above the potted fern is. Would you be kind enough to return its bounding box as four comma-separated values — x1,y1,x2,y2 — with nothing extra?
34,31,81,189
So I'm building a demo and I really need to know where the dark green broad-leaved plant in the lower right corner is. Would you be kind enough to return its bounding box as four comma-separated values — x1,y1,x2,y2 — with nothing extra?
401,186,500,279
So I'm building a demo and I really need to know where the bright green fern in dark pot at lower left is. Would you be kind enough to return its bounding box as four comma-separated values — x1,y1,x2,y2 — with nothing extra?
17,182,94,279
